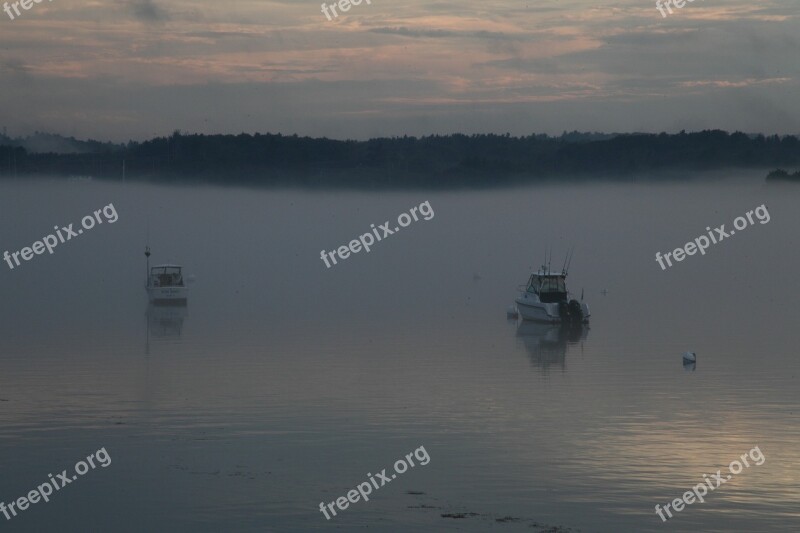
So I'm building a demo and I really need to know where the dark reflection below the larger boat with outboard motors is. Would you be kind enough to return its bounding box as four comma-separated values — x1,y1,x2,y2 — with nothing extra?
517,320,589,372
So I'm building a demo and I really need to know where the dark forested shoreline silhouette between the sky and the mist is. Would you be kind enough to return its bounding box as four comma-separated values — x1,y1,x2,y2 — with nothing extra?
0,130,800,187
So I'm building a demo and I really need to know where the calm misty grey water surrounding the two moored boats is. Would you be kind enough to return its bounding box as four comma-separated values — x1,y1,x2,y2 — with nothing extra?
0,172,800,532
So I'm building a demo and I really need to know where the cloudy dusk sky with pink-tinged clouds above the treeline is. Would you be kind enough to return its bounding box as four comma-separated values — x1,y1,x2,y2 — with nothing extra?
0,0,800,142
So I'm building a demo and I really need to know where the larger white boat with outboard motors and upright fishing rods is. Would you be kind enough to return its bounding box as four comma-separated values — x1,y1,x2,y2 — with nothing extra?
514,267,590,324
